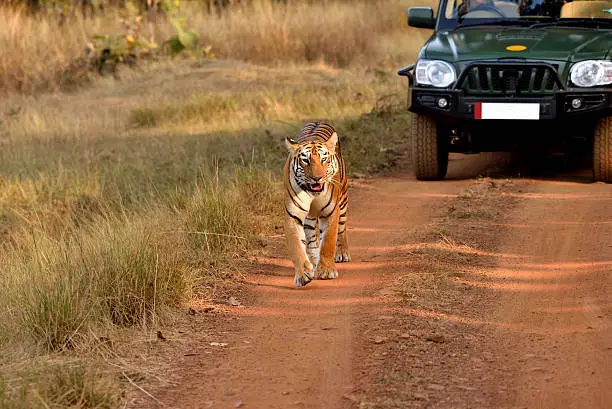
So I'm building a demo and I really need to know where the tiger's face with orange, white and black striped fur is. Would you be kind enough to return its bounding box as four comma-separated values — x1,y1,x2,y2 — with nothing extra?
287,134,339,193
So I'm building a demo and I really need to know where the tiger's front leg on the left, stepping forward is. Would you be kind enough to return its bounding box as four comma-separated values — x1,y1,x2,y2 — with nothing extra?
285,212,314,287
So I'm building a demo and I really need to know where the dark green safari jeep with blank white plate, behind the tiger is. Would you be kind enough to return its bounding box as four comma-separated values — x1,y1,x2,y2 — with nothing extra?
398,0,612,183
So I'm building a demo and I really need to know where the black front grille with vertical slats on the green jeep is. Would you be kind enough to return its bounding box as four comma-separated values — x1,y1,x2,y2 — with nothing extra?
455,63,563,97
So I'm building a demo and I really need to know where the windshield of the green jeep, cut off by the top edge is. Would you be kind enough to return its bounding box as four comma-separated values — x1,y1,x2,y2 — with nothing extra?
439,0,612,29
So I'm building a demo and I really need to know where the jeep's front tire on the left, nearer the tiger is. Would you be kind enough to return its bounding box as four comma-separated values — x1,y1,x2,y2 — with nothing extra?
411,114,448,180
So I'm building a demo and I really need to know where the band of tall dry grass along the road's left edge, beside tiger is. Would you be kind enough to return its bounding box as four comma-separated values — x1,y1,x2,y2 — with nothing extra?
0,165,268,351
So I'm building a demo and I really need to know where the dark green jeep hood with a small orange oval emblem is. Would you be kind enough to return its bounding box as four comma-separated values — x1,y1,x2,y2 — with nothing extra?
419,26,612,65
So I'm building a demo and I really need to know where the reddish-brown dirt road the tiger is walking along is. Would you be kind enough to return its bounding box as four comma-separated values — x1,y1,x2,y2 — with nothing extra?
130,155,612,409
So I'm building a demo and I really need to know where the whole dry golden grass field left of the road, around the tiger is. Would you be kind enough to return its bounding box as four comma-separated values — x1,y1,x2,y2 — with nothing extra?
0,62,416,407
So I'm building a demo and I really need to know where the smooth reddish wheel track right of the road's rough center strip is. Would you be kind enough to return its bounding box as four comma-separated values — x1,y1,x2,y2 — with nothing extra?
478,181,612,409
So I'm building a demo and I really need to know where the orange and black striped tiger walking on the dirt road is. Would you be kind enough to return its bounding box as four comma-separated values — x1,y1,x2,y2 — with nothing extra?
283,122,351,287
